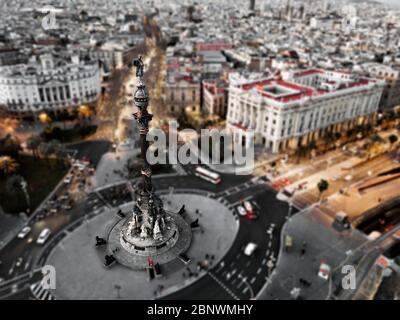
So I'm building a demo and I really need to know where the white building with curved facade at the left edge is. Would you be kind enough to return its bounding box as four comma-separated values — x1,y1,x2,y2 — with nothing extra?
0,54,101,114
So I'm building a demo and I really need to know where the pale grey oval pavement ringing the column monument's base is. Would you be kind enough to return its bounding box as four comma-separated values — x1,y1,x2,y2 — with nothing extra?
46,194,239,300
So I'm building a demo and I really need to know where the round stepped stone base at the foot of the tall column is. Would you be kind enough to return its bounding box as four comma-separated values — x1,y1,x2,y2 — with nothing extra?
107,213,192,270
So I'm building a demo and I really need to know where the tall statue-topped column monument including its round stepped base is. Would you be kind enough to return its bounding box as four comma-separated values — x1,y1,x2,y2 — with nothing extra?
107,57,192,269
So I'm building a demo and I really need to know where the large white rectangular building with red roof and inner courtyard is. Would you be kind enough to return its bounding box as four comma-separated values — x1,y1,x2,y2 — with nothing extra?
227,69,384,152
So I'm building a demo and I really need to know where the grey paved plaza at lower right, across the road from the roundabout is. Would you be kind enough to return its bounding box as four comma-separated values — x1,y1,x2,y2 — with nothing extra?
258,207,367,300
